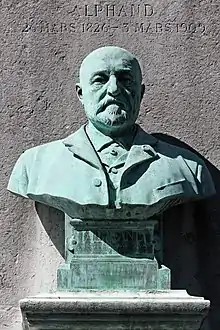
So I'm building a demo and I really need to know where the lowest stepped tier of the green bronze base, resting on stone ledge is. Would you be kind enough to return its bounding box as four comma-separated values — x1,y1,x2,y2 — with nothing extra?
57,257,171,292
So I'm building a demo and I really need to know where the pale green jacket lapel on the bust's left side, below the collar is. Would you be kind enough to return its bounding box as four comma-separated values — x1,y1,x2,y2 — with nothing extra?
63,125,102,169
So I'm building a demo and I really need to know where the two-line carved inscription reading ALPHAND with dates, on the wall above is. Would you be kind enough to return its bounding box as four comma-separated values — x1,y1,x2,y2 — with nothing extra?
22,3,206,36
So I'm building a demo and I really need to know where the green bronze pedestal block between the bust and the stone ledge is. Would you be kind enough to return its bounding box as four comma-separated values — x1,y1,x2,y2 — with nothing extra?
57,216,171,292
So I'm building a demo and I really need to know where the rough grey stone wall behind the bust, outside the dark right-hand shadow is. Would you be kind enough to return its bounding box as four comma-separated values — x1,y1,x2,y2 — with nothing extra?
0,0,220,330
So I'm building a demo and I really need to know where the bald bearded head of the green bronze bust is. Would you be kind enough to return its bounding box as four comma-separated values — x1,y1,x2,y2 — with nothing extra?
76,46,144,135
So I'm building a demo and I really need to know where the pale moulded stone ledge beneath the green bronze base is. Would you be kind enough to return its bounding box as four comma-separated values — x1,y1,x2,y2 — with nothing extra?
20,290,209,330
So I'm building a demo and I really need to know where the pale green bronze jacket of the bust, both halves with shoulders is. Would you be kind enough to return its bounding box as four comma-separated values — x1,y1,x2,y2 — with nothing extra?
8,126,214,219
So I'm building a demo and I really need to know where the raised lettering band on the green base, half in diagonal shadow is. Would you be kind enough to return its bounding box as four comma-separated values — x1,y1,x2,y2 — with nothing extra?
71,223,161,259
